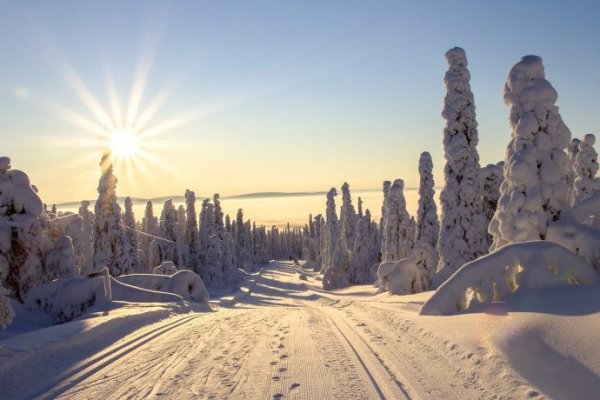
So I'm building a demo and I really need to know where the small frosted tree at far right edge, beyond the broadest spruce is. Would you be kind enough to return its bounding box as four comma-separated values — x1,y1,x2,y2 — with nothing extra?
573,133,600,204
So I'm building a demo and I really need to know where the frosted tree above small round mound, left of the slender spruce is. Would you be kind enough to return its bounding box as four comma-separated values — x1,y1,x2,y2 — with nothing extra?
381,179,412,261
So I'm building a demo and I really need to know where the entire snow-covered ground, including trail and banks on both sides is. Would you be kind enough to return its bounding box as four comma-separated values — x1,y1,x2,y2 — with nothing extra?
0,262,600,399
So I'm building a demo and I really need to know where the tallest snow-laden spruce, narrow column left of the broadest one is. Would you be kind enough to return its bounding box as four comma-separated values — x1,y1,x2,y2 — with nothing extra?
438,47,488,281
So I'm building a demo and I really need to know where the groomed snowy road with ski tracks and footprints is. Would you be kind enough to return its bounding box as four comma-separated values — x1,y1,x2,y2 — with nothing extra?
0,263,540,399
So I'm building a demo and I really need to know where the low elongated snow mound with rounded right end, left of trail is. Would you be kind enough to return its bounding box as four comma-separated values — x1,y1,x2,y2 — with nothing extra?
115,263,209,303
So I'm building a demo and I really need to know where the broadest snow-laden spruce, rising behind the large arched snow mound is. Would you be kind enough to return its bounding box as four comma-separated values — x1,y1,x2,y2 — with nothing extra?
489,56,571,251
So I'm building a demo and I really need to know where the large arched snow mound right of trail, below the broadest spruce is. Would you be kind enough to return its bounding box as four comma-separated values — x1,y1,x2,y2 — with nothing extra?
421,241,600,315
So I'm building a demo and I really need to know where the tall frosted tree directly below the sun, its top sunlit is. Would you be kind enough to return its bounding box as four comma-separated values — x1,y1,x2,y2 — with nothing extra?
94,153,133,275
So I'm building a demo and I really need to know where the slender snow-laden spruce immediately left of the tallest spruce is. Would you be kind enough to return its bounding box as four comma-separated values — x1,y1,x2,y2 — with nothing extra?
413,151,440,287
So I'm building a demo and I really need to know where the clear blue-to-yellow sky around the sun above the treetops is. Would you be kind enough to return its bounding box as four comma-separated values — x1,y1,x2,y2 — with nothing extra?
0,0,600,203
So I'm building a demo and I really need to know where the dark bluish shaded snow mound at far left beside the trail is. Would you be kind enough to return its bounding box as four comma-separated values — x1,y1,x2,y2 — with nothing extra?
25,270,111,323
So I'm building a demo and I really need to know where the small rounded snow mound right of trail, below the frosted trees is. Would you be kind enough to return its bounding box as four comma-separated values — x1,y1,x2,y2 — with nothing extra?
377,257,429,294
